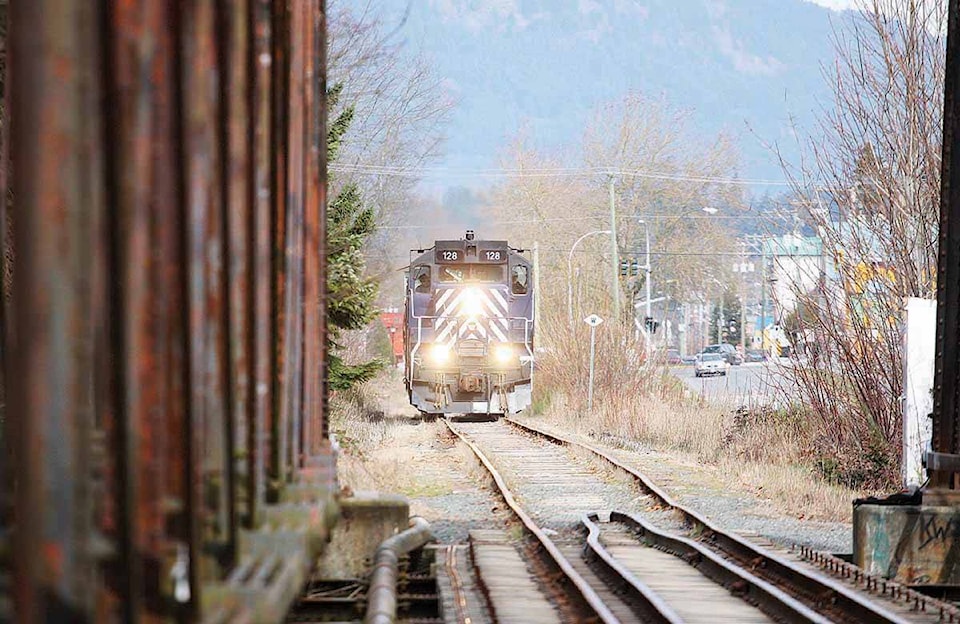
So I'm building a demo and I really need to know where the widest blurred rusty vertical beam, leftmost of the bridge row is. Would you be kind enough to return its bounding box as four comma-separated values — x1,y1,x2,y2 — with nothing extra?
8,0,103,622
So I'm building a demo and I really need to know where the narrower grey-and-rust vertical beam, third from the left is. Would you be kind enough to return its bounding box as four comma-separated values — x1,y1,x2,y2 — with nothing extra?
180,0,230,581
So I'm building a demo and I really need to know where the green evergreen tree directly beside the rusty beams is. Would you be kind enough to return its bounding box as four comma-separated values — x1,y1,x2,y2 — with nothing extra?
327,84,384,390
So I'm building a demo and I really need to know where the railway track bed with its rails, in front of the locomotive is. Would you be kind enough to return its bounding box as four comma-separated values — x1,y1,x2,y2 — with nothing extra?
446,419,960,622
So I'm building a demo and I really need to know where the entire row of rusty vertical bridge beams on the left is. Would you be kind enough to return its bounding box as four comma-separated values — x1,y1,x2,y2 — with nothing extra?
0,0,335,622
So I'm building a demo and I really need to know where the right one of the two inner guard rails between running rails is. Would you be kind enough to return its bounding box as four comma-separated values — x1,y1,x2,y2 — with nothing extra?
596,511,830,624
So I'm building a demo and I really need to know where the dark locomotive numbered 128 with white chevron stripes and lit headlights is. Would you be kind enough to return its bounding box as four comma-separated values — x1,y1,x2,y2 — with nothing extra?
403,230,537,418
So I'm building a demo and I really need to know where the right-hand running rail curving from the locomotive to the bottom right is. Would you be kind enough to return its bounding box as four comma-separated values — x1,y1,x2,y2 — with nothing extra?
503,418,929,624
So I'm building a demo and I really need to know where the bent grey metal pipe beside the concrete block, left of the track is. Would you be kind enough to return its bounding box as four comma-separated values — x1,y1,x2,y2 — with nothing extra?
363,516,433,624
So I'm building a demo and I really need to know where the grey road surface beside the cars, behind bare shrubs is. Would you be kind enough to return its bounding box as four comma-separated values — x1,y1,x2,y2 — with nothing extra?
670,362,787,406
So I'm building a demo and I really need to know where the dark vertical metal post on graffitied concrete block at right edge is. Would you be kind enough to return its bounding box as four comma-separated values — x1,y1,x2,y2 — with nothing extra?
930,0,960,488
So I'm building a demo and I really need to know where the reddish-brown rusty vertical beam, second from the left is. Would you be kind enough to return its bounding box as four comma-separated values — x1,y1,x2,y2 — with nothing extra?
104,1,192,620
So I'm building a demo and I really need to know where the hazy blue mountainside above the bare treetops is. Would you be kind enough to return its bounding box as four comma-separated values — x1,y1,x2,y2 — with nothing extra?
372,0,844,197
